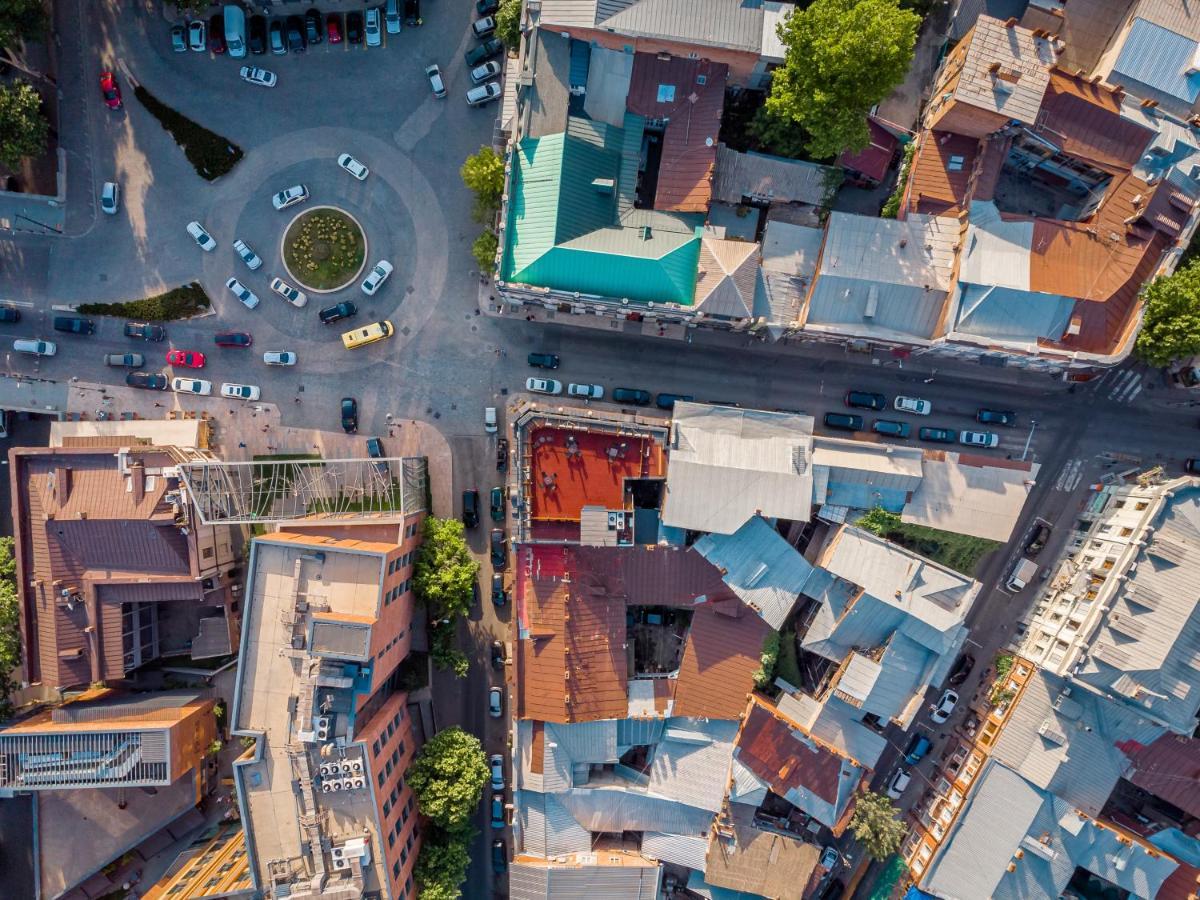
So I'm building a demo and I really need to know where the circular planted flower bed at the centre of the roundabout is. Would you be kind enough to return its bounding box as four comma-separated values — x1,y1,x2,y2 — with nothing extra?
283,206,367,290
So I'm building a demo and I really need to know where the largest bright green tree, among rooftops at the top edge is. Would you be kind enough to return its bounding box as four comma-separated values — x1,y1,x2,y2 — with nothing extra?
767,0,920,160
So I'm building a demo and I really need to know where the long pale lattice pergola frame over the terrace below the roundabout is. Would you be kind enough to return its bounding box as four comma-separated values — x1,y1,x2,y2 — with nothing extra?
179,456,428,524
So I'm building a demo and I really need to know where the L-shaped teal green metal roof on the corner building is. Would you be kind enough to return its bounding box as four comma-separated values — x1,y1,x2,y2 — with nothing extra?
500,126,702,306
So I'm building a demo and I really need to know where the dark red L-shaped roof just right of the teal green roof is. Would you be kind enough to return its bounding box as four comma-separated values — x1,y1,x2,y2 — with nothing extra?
625,53,728,212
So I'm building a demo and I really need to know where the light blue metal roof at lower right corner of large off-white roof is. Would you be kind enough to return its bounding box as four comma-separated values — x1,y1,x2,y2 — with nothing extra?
695,516,812,631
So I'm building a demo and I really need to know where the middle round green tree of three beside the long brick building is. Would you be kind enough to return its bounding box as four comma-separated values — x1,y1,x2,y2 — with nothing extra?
407,725,491,830
